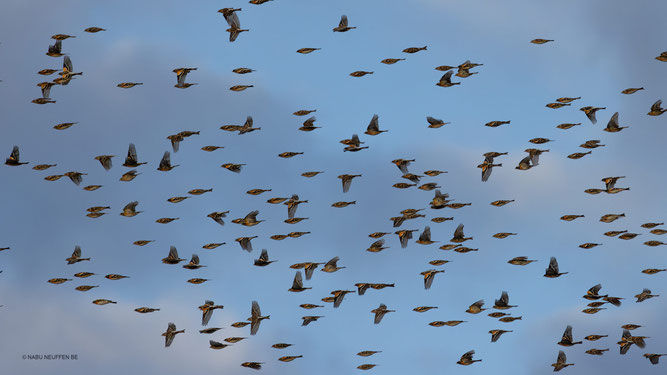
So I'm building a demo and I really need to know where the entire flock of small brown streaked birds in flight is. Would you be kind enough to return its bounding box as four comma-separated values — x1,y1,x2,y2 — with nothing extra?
0,0,667,371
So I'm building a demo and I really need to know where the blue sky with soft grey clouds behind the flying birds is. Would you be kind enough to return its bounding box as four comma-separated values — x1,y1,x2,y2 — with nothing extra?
0,0,667,374
